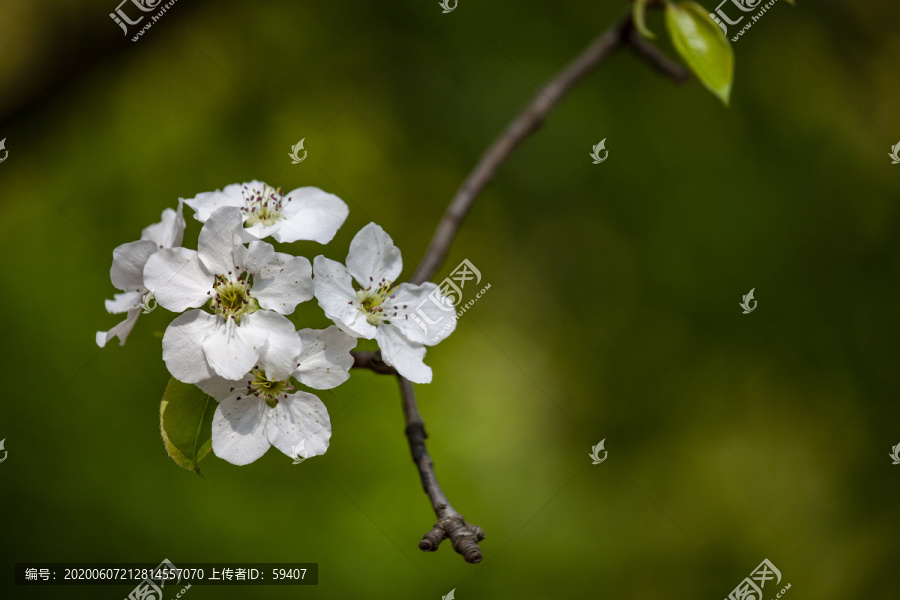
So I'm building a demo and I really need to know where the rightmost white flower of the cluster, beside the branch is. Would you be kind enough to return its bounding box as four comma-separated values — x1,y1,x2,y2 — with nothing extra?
313,223,456,383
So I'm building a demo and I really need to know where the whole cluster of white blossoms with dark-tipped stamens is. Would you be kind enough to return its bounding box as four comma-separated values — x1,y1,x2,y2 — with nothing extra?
97,181,455,465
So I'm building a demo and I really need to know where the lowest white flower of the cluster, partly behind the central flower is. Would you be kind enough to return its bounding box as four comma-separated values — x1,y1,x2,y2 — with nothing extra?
197,326,356,465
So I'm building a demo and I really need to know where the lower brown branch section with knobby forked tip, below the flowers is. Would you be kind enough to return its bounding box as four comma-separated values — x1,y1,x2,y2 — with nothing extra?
397,375,484,564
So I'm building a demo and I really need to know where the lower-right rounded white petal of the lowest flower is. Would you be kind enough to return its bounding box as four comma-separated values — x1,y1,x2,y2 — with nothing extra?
266,392,331,458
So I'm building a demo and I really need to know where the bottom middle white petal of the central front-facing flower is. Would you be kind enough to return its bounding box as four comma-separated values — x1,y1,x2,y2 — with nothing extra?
198,315,268,381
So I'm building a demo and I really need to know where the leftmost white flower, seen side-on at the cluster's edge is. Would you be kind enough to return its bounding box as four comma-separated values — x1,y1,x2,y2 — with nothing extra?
96,200,184,348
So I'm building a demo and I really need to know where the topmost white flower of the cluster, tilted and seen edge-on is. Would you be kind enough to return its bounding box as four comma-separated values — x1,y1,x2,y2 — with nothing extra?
184,180,349,244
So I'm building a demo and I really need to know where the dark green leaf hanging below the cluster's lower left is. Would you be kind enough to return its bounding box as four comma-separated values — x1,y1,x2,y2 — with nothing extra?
159,378,217,475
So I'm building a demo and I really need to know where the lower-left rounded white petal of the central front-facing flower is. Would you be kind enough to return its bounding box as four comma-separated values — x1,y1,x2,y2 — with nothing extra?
163,310,218,383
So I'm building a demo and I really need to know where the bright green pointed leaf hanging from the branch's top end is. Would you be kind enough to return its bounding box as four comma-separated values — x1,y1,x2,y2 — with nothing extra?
666,2,734,106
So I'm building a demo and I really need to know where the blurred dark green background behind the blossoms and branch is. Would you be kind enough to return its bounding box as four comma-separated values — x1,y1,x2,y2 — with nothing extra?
0,0,900,600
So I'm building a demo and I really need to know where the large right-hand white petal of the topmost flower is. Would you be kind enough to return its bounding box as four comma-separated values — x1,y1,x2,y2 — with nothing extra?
271,187,350,244
